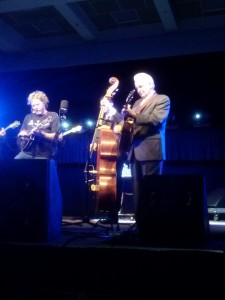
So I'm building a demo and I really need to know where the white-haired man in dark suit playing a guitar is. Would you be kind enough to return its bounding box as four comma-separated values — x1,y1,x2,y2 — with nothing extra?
104,73,170,218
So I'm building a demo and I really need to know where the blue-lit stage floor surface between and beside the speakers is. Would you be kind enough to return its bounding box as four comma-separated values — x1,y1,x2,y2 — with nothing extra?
44,214,225,250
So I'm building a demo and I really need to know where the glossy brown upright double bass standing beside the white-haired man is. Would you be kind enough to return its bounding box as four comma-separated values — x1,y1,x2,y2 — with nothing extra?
91,77,119,211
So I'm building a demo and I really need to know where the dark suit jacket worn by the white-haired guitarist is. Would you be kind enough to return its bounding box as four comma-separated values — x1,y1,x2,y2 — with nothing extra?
115,94,170,161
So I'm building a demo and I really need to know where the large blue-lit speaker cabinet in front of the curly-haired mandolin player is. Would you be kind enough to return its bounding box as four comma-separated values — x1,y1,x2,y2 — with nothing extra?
0,159,62,242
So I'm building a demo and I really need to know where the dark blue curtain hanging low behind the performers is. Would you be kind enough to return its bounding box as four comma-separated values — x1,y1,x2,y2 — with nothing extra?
56,128,225,164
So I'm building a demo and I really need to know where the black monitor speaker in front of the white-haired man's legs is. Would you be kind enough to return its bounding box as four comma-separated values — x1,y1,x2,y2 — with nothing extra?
136,174,209,246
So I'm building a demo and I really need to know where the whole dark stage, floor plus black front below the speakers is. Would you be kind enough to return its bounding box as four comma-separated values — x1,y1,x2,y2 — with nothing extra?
0,215,225,300
